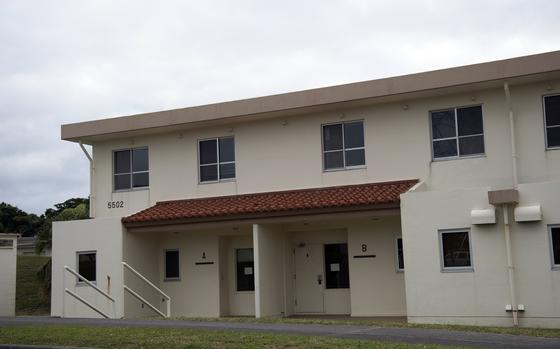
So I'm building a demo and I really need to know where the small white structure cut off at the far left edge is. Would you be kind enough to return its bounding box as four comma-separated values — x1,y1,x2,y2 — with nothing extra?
0,234,17,316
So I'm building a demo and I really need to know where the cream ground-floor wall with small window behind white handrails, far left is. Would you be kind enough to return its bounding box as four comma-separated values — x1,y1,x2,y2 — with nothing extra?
51,218,124,318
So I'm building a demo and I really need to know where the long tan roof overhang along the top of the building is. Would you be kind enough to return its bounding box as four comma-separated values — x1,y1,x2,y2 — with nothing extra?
61,51,560,144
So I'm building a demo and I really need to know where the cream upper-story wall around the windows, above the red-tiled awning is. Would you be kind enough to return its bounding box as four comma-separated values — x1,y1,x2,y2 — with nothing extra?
87,82,560,217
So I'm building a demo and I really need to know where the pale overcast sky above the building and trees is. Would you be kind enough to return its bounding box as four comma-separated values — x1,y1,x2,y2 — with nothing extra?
0,0,560,213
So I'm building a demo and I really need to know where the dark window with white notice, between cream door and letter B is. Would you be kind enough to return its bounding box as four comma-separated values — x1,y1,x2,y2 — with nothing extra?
325,244,350,289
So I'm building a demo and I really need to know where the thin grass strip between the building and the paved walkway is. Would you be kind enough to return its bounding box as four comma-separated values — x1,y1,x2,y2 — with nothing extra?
175,317,560,338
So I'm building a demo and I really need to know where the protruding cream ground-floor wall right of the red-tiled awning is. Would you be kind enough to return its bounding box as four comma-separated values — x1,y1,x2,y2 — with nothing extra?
401,182,560,327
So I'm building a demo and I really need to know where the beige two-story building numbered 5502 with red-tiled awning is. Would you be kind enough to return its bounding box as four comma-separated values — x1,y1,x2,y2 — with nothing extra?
52,51,560,327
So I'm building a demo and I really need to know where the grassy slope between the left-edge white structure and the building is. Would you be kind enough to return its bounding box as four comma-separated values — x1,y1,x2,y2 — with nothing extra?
16,256,51,315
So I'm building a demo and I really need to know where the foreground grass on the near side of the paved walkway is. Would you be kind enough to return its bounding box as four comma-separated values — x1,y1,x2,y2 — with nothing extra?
0,326,466,349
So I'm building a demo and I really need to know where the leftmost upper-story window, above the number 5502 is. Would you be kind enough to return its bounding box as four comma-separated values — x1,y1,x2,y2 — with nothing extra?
113,148,150,190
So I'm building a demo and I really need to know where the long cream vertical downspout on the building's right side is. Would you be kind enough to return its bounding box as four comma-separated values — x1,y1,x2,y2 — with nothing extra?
502,81,519,327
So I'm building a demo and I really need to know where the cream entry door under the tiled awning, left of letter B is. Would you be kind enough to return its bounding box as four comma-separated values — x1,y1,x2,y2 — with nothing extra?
295,244,325,313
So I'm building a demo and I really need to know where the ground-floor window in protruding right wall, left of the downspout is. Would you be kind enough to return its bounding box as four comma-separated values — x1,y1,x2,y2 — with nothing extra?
439,229,472,270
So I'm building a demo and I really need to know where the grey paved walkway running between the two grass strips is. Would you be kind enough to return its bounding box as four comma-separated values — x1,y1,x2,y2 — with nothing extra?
0,317,560,349
